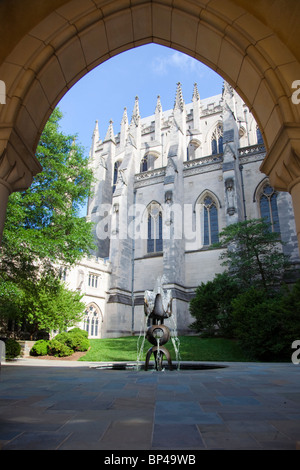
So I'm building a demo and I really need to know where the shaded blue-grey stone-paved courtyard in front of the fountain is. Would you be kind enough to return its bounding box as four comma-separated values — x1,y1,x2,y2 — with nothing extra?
0,359,300,451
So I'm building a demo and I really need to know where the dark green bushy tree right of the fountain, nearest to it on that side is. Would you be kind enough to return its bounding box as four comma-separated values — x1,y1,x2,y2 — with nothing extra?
189,273,239,337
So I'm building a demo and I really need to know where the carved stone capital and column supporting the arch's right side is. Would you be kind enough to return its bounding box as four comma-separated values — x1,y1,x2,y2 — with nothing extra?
260,123,300,250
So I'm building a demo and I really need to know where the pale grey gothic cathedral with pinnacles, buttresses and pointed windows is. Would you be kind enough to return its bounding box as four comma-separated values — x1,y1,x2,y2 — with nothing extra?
67,82,299,337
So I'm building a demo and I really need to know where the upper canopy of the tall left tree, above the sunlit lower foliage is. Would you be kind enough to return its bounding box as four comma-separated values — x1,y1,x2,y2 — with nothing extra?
0,109,93,278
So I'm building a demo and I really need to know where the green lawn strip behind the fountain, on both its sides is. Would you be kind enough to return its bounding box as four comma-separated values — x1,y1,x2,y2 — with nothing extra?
80,336,249,362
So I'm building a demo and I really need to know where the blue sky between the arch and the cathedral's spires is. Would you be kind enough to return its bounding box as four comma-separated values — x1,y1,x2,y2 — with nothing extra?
58,44,223,155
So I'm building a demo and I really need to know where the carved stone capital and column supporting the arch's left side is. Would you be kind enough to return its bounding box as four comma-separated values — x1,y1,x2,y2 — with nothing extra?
0,128,42,244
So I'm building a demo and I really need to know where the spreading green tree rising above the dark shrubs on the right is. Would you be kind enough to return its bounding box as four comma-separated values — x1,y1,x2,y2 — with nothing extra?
214,219,290,290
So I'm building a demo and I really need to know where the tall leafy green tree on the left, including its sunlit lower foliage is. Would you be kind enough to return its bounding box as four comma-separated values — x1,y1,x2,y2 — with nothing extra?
0,109,93,338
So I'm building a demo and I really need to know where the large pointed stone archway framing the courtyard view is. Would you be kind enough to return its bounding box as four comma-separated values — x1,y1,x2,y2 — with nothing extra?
0,0,300,246
